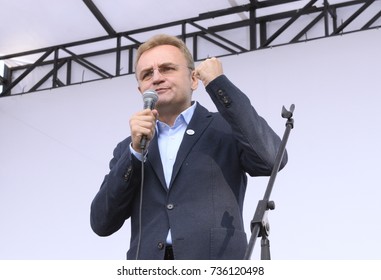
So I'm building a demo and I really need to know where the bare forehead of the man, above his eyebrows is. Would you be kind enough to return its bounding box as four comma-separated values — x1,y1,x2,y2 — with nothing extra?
136,45,186,71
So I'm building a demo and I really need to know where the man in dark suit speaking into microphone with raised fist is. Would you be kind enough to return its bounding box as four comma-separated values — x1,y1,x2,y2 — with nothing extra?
91,35,287,260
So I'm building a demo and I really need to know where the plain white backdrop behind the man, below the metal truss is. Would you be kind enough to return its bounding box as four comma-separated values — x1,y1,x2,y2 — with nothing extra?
0,30,381,260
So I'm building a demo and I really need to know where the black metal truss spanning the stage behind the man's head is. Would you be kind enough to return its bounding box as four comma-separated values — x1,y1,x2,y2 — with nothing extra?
0,0,381,97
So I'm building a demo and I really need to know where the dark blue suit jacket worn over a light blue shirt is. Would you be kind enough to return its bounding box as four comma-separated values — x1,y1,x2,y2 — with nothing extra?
91,76,287,259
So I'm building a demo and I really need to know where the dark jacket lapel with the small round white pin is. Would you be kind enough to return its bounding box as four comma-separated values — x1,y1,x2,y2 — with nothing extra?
169,104,212,188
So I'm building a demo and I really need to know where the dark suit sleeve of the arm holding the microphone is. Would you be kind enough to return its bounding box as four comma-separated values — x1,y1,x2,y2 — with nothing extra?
90,138,141,236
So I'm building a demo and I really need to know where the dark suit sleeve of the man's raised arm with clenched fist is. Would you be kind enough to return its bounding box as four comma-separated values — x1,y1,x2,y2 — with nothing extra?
206,75,287,176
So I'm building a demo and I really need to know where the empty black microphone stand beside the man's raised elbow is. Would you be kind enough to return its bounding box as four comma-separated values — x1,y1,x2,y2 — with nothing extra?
244,104,295,260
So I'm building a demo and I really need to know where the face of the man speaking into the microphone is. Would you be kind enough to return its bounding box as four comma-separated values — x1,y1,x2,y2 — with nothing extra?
136,45,198,113
